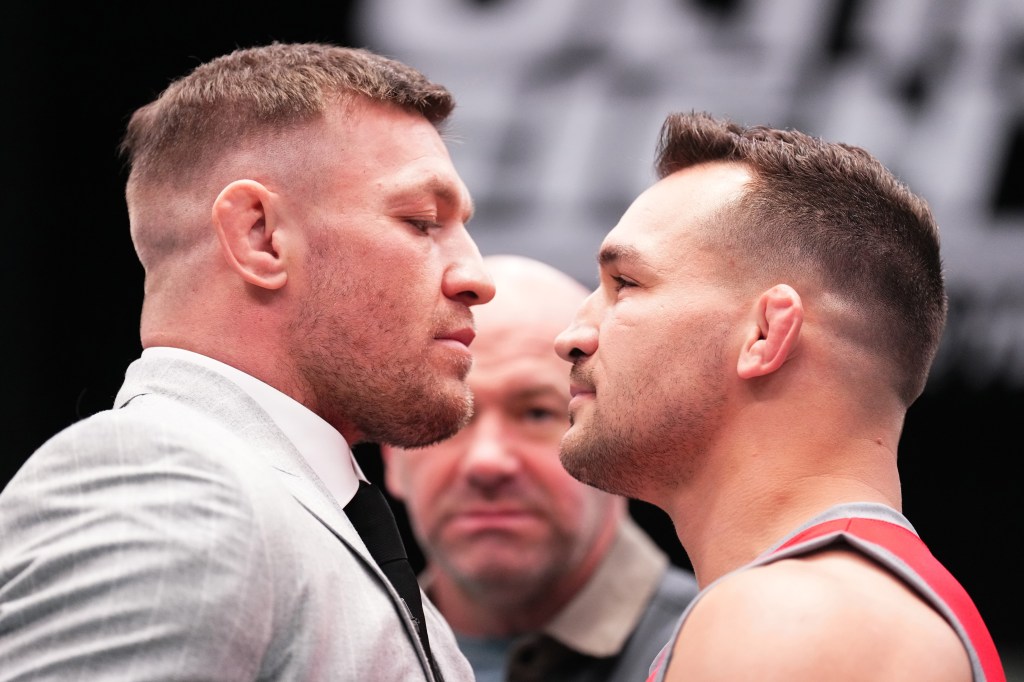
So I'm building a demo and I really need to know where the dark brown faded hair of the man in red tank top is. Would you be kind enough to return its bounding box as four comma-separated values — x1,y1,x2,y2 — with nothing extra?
655,112,948,406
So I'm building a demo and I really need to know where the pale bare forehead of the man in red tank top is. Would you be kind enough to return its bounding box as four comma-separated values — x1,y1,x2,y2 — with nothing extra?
598,162,751,266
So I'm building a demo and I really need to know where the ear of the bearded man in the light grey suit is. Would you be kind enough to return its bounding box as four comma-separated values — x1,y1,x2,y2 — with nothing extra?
213,180,288,290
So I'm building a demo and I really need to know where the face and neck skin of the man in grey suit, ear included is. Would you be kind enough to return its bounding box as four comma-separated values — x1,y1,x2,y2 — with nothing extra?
133,99,494,445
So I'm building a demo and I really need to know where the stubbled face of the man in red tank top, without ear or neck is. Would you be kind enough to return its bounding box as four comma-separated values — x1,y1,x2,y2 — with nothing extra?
556,164,748,504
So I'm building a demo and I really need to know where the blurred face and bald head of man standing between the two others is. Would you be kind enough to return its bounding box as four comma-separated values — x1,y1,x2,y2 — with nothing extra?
383,256,625,636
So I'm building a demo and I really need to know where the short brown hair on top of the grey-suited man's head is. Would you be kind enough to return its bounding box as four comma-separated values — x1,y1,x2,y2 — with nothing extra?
120,42,455,186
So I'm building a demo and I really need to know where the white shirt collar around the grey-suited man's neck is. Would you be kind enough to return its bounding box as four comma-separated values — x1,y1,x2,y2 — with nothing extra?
142,346,366,507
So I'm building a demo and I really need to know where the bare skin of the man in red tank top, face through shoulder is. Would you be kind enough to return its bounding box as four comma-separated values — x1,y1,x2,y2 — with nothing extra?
556,162,971,682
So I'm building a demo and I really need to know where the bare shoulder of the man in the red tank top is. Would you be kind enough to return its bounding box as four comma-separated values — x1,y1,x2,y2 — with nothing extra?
668,550,971,682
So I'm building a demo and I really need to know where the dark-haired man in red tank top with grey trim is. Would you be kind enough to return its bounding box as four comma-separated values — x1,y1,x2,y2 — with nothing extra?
556,113,1005,682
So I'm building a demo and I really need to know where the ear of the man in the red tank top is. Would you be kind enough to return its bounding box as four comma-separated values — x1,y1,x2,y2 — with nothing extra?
736,285,804,379
